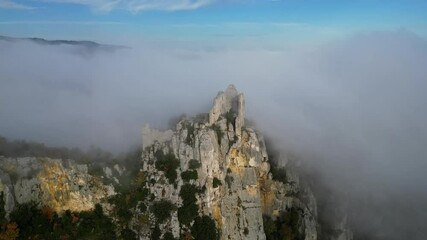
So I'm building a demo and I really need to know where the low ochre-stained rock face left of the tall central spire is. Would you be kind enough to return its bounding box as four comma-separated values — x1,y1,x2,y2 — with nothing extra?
0,157,114,213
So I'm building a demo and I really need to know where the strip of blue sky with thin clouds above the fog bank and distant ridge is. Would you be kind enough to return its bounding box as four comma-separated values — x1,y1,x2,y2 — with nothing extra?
0,0,427,47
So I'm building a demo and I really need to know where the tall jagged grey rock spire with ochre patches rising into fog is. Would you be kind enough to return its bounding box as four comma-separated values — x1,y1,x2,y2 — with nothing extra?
142,85,324,240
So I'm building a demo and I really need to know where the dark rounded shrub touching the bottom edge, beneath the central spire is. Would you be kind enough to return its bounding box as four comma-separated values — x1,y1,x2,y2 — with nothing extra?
191,216,219,240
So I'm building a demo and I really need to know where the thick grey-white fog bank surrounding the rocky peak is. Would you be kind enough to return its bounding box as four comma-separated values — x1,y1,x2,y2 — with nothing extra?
0,30,427,239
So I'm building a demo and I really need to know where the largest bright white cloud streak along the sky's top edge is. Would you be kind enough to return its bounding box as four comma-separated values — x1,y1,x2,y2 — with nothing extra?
42,0,215,13
